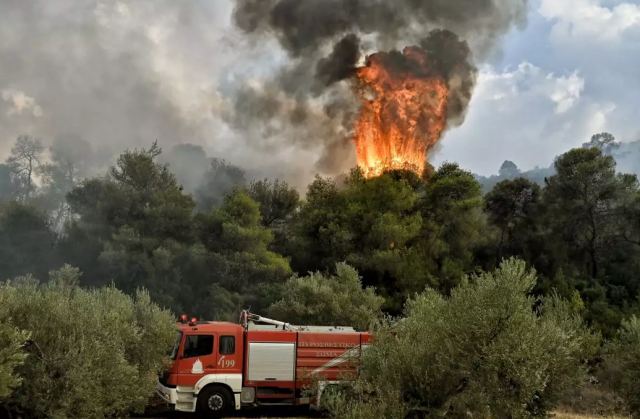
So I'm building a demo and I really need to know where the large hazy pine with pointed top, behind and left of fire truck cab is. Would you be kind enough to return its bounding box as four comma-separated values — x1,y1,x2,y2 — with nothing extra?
61,144,200,310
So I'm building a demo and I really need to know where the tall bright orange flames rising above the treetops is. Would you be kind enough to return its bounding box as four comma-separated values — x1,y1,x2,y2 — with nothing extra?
354,47,449,177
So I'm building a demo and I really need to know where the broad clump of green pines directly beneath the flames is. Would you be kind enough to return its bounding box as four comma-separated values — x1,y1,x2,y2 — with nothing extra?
289,164,484,312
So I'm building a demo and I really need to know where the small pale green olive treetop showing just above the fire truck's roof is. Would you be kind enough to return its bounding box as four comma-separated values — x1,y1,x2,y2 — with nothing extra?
269,263,384,330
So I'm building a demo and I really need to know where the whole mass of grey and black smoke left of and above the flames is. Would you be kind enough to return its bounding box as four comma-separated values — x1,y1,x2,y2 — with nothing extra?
0,0,526,187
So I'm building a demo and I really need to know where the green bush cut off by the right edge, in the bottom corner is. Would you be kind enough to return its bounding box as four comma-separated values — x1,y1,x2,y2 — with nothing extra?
604,316,640,414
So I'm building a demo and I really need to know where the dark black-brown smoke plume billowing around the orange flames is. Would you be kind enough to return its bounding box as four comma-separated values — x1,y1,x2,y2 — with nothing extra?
227,0,527,172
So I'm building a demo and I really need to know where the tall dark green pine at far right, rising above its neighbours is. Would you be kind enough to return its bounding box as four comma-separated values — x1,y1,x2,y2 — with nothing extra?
541,148,640,335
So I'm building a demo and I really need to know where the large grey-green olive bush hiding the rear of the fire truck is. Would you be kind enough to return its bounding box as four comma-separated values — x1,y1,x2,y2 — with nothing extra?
333,259,597,418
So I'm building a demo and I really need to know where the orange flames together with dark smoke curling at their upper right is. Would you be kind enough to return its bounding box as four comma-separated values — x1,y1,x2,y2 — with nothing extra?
354,30,476,177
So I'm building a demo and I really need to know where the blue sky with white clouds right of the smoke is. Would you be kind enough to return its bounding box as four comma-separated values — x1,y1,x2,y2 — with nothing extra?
434,0,640,175
